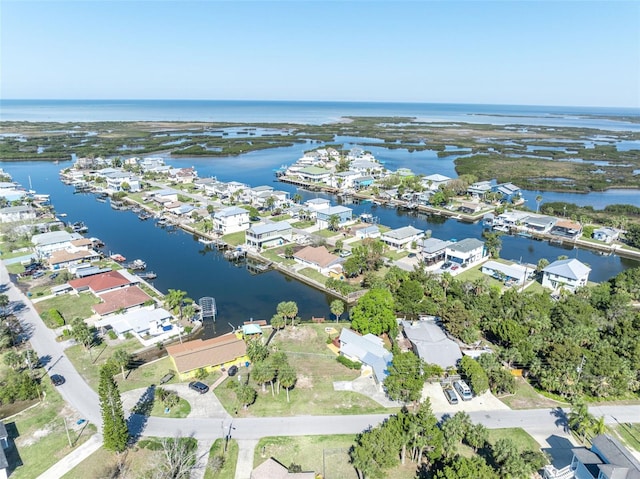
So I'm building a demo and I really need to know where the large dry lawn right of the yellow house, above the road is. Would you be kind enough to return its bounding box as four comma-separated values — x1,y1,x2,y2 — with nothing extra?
216,325,393,417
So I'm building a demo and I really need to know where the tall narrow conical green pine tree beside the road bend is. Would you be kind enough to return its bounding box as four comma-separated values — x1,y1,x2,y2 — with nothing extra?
98,364,129,452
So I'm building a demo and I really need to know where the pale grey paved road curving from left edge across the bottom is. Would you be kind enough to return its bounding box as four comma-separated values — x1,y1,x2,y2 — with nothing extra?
5,264,640,476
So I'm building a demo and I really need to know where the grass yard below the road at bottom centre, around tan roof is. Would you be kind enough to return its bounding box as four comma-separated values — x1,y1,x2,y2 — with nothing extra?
253,434,358,479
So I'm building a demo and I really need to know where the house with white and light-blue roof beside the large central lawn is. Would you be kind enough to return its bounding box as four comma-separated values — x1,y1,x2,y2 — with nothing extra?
339,328,393,388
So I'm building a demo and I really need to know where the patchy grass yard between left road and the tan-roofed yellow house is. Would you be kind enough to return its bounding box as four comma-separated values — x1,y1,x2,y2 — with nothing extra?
65,339,144,391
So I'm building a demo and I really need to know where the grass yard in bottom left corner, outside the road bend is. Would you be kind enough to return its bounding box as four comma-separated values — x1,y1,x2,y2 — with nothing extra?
4,382,96,479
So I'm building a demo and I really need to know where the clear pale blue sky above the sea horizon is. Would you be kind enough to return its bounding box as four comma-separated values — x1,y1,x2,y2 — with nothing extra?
0,0,640,108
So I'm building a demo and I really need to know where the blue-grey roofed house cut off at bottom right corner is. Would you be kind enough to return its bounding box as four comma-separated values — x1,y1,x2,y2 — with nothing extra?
543,434,640,479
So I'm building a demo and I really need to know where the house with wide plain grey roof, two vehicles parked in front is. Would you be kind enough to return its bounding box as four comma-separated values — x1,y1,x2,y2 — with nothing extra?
400,318,462,369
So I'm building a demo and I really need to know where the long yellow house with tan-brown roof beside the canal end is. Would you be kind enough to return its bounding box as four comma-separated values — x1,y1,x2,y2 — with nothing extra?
167,333,248,380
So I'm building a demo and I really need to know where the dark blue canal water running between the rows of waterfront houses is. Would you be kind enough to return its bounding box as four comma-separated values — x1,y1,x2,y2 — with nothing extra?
0,138,640,336
